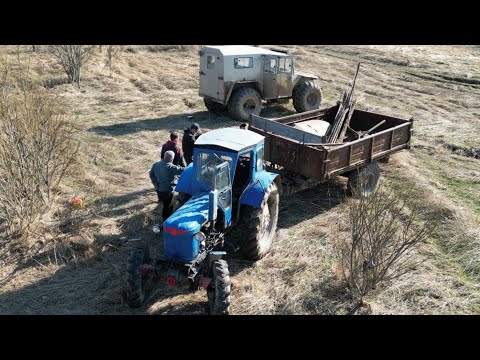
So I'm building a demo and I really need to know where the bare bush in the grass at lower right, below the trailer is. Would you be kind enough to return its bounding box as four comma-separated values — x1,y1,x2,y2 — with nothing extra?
337,183,435,305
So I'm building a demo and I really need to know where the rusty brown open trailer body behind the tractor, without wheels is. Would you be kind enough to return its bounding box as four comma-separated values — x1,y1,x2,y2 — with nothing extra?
249,105,413,181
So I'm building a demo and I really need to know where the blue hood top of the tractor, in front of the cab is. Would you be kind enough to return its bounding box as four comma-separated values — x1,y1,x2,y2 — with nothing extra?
163,192,208,236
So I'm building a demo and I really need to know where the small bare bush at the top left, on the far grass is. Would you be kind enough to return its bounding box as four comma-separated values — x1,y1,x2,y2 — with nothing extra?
51,45,94,88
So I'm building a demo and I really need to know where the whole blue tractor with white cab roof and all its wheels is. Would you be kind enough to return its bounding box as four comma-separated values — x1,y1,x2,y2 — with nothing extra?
127,128,281,314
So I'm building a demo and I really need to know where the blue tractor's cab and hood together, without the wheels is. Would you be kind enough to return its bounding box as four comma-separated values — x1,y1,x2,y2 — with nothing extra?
164,128,265,261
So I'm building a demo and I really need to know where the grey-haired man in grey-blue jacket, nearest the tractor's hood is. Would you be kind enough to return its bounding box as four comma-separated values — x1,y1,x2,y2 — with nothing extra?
150,150,185,221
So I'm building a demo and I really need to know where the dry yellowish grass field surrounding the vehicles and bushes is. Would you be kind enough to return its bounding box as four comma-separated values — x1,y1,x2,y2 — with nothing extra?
0,45,480,314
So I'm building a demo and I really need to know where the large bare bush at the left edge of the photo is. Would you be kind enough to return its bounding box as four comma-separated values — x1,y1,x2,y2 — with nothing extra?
0,63,78,240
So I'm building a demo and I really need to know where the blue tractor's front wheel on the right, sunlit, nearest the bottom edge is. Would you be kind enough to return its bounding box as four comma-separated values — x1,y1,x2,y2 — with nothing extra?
207,260,231,315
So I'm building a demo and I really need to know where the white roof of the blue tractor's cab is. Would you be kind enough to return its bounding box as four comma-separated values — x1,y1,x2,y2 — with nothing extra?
195,128,264,152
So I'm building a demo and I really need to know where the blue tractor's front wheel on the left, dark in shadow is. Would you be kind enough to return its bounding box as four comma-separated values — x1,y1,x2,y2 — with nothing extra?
126,246,150,308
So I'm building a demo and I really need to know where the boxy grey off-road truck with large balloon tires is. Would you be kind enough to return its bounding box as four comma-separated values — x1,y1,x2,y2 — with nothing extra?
199,45,322,121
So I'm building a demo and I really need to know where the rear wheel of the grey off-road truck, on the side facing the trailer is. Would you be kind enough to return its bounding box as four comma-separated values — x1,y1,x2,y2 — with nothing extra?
228,87,262,122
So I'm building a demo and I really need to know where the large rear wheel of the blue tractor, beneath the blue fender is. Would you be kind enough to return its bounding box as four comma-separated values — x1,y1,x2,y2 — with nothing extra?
239,182,280,260
